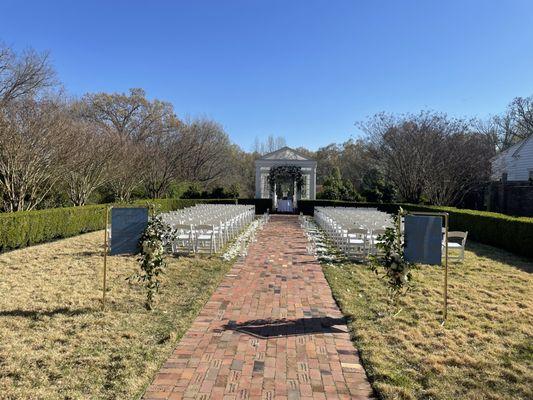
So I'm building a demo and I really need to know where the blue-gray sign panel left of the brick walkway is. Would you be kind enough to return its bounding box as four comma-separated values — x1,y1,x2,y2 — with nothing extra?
110,208,148,255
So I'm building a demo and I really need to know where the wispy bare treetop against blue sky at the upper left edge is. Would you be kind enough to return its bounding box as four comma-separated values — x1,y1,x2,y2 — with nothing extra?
0,43,55,107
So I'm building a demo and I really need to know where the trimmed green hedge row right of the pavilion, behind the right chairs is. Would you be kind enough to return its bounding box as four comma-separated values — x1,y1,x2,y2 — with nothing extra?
299,200,533,258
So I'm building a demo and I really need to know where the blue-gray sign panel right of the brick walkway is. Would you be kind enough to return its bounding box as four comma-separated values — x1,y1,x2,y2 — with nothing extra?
404,215,442,265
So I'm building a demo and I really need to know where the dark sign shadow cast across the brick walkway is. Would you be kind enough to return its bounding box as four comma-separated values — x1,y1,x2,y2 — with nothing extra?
224,317,347,339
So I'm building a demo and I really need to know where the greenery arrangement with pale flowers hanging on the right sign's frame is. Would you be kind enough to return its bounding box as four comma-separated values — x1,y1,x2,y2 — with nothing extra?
370,208,414,304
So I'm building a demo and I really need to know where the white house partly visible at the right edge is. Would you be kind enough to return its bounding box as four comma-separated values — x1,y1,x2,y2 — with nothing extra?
491,136,533,182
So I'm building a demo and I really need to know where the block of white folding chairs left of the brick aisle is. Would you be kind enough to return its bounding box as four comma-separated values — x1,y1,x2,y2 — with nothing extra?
161,204,255,254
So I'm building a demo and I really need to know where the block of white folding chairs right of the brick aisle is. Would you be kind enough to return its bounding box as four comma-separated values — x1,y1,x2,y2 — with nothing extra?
315,207,393,258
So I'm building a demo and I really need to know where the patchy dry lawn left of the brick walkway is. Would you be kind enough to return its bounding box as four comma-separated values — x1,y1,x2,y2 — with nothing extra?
0,232,230,400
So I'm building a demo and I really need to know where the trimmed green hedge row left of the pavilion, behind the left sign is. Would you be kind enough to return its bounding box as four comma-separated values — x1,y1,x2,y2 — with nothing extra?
0,199,271,252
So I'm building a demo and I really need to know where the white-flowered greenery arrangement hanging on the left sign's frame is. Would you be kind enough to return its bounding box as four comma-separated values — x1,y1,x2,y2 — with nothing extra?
128,216,170,310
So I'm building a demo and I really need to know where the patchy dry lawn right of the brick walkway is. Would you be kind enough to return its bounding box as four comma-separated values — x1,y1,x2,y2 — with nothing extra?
324,243,533,400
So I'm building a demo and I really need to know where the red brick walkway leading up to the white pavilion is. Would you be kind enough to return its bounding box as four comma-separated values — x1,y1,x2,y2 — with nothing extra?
144,215,372,400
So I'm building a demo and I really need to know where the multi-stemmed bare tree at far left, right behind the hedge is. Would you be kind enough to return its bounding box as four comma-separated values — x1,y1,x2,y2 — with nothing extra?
0,100,70,211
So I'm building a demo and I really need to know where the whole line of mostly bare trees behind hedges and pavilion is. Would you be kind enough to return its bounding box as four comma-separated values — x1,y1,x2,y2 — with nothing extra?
0,45,533,211
